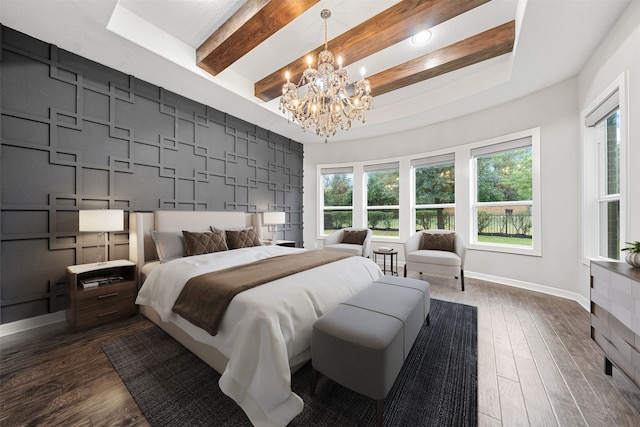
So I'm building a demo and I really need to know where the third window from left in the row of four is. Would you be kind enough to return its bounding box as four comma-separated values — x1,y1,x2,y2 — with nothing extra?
411,154,456,231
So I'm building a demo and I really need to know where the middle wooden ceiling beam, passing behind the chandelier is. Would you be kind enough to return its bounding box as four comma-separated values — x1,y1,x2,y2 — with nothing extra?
254,0,490,101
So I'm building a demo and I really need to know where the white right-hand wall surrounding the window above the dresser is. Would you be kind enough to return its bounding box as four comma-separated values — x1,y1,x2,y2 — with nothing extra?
578,1,640,295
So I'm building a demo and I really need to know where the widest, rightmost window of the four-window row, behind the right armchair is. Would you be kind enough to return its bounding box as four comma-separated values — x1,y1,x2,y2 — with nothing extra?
471,137,535,249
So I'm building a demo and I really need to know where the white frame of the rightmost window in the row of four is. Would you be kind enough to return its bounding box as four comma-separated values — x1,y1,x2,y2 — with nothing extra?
468,128,542,257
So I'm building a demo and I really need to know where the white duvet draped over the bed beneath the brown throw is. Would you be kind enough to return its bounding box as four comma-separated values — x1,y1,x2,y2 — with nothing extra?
136,246,382,426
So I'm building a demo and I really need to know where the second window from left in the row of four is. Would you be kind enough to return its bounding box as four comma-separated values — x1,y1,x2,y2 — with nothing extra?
364,163,400,237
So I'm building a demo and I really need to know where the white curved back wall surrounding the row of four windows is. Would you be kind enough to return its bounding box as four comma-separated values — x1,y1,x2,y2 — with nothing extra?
304,78,584,303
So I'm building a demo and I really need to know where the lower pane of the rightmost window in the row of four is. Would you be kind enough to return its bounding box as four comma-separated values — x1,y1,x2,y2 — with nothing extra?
478,205,533,247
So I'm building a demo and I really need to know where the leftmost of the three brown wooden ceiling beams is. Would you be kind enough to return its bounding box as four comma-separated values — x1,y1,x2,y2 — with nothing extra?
196,0,320,76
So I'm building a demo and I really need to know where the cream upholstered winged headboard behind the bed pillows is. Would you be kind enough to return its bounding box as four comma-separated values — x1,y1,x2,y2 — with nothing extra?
129,211,264,284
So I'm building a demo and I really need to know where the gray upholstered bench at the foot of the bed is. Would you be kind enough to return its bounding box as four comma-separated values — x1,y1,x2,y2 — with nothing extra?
311,276,431,426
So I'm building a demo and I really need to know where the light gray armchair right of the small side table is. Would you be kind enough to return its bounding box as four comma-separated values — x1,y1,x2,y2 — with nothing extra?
404,230,467,291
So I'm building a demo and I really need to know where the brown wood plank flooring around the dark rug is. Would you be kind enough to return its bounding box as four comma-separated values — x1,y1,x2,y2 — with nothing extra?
0,275,640,426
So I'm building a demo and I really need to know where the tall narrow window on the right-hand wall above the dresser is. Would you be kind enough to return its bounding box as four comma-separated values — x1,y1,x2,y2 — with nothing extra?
585,90,622,260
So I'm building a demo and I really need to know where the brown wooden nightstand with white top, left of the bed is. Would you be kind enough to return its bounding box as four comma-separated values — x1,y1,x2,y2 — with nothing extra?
67,260,138,329
